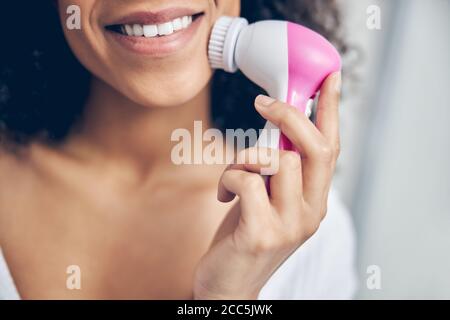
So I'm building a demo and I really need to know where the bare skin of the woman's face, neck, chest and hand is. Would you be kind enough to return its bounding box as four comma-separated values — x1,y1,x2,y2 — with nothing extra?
0,0,341,299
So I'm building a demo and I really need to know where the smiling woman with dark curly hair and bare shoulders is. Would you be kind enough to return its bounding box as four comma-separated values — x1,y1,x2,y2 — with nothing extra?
0,0,354,299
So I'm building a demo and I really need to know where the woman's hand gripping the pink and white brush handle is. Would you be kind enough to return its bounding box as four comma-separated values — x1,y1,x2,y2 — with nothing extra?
194,73,341,299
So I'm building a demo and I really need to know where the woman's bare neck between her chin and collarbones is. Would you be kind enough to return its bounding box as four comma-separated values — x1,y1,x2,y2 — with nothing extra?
67,79,211,178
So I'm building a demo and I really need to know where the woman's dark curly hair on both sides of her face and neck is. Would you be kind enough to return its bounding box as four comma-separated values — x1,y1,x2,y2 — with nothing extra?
0,0,347,144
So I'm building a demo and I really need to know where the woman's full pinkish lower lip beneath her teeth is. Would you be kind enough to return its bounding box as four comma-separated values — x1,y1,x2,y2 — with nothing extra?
106,15,203,56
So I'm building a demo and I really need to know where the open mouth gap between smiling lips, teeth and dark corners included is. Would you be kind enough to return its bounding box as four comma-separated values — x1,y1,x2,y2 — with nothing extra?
105,12,204,38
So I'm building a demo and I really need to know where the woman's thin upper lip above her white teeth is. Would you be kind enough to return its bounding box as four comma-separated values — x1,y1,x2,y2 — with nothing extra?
107,8,203,25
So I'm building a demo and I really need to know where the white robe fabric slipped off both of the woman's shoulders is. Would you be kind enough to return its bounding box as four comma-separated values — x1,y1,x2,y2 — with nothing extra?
0,190,357,300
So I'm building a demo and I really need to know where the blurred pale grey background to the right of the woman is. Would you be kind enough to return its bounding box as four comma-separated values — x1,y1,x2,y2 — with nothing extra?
335,0,450,299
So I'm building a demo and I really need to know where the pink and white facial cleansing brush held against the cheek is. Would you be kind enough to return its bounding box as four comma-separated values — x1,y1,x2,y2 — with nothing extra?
209,16,341,150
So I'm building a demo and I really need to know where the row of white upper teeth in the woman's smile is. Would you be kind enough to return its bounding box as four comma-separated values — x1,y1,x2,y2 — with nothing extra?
121,16,193,38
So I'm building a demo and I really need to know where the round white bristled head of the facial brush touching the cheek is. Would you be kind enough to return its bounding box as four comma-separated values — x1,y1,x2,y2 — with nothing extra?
208,16,248,72
